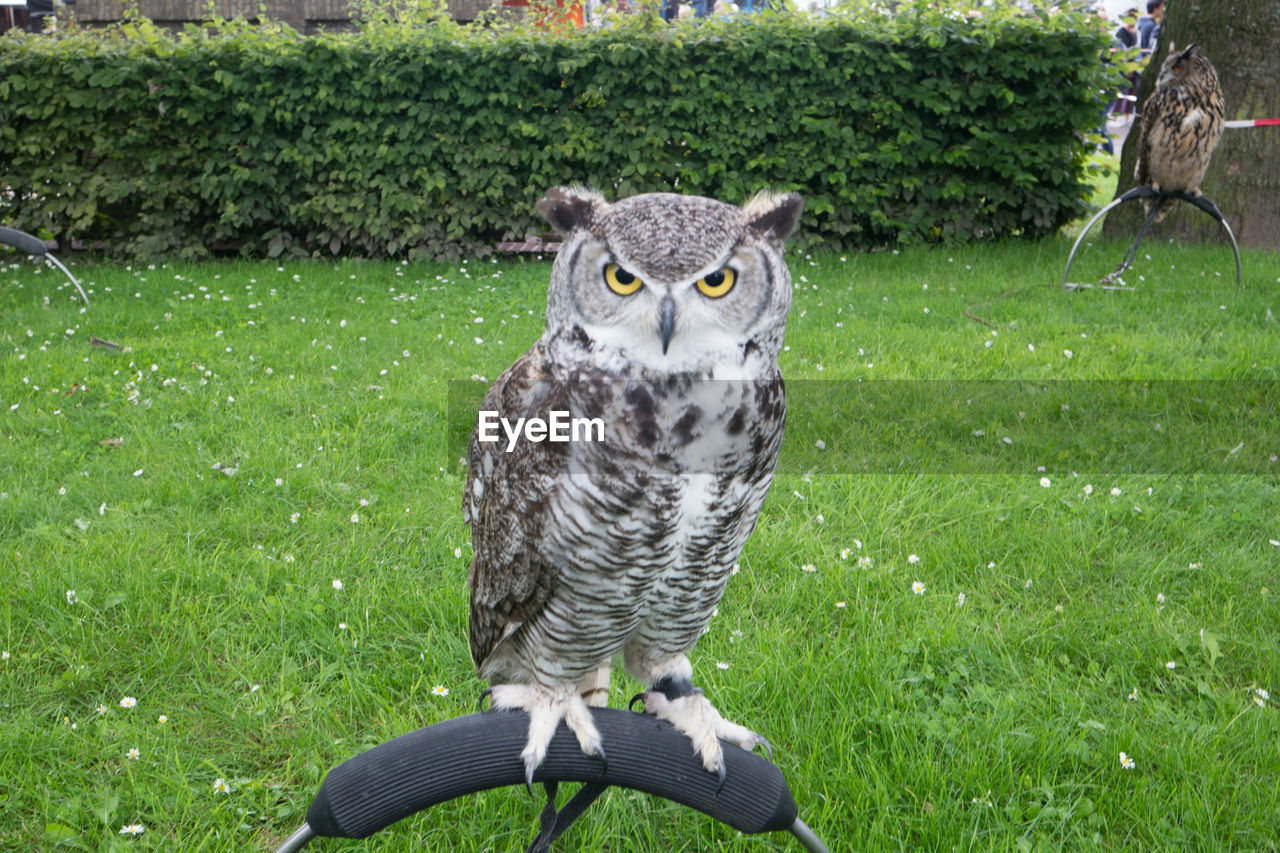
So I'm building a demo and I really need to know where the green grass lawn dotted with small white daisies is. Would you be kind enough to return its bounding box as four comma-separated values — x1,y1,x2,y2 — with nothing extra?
0,229,1280,850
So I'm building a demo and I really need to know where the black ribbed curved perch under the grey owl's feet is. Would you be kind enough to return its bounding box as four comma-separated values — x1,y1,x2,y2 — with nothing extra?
275,708,829,853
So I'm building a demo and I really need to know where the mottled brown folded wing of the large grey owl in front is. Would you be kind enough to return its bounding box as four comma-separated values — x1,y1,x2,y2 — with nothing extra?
462,342,568,670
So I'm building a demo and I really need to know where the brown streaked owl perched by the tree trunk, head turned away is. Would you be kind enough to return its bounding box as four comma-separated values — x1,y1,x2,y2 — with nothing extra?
1134,45,1225,222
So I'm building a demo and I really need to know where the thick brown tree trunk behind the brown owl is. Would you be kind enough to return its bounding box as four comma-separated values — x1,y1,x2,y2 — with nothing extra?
1105,0,1280,248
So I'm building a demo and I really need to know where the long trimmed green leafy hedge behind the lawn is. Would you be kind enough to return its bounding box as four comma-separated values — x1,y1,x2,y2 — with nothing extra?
0,5,1105,256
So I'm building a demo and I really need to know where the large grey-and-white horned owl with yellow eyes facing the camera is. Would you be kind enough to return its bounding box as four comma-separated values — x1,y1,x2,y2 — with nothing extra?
463,187,803,783
